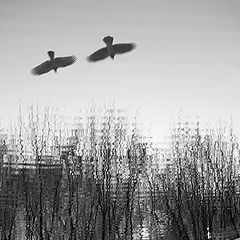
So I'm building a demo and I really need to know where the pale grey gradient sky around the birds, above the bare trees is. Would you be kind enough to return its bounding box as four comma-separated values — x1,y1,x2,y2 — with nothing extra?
0,0,240,141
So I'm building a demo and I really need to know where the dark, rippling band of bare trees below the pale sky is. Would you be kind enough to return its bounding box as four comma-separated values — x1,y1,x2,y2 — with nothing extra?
0,109,240,240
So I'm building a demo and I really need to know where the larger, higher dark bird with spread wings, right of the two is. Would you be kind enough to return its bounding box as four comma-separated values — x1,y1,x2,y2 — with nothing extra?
87,36,136,62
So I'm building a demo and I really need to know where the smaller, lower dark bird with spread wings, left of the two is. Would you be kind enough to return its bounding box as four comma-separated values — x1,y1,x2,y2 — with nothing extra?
31,51,77,75
